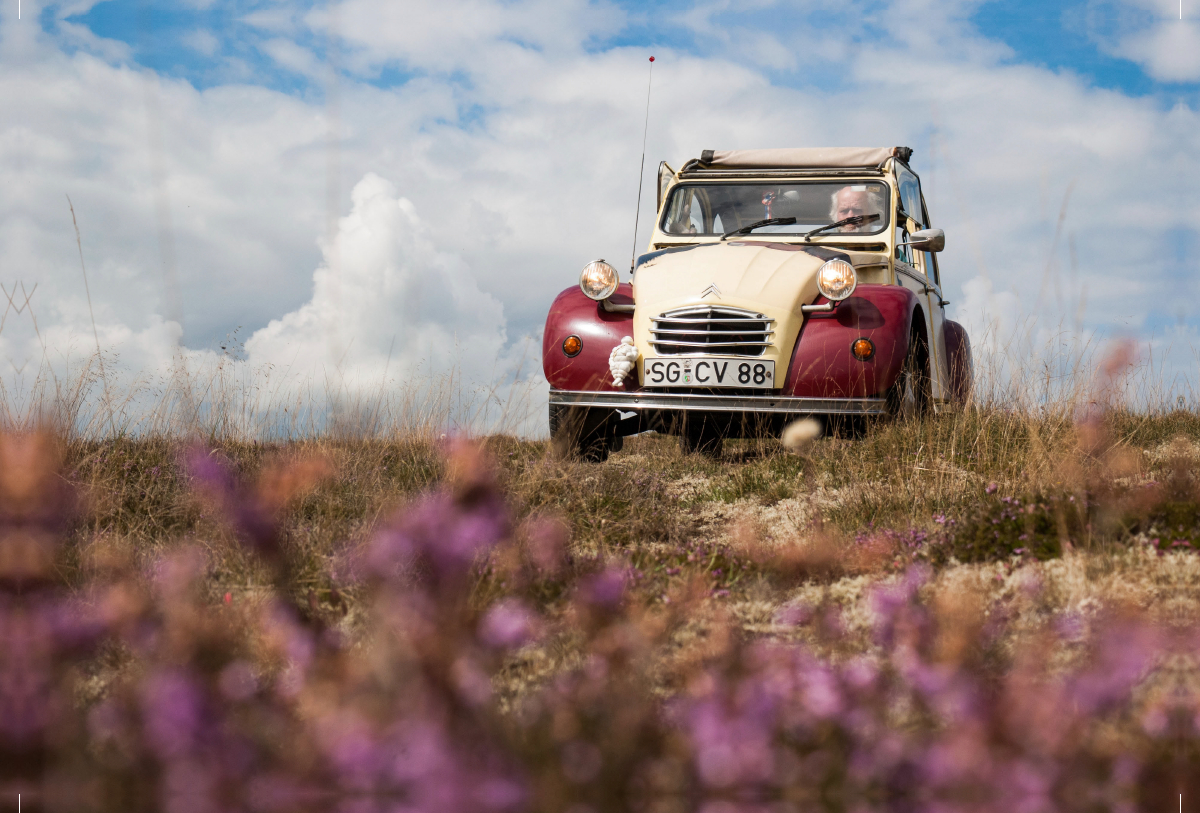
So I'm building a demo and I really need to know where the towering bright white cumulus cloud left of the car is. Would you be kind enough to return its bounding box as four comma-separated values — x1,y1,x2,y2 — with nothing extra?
246,173,508,395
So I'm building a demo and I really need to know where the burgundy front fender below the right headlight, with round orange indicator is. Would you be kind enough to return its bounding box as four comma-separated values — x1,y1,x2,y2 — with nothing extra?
782,284,918,398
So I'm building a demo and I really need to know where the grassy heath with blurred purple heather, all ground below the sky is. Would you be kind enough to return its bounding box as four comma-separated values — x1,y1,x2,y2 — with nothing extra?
7,378,1200,813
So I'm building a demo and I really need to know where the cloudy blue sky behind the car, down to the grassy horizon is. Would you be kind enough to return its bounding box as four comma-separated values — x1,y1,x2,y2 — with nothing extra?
0,0,1200,432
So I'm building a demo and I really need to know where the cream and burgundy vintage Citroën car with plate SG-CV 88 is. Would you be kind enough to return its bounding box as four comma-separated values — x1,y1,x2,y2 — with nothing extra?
542,147,972,459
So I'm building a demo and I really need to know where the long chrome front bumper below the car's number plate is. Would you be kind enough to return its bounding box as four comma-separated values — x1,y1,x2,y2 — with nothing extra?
550,390,887,417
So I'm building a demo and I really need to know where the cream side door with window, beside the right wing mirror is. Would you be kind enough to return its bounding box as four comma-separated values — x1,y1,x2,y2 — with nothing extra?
895,167,949,399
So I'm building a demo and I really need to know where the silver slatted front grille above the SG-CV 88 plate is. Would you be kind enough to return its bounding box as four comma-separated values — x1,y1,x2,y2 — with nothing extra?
650,305,775,356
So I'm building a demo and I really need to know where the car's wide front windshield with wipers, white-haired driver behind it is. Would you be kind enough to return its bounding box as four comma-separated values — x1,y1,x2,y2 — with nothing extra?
661,180,889,236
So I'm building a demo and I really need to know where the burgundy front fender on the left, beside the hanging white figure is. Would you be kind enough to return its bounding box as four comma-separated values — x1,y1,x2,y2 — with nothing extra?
541,283,638,392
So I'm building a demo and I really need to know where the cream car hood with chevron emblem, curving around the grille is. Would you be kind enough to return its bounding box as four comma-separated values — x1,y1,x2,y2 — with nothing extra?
634,240,848,384
